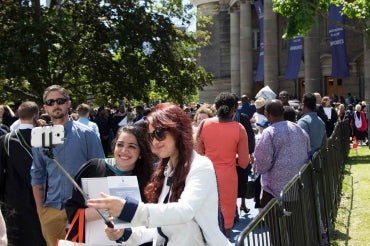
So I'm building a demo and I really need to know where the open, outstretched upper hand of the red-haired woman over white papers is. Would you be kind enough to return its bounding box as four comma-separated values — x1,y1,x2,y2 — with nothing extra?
87,193,126,217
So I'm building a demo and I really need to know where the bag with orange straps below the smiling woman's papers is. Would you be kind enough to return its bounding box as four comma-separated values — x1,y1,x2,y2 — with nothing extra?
56,208,85,246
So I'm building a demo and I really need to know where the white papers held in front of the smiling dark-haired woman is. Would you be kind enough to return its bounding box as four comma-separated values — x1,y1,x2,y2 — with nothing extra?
81,176,141,246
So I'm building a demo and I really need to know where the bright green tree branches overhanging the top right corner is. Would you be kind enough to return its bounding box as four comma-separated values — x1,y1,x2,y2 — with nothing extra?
273,0,370,102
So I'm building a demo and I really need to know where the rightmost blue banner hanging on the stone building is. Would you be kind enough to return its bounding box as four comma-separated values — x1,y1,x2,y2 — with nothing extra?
329,5,349,78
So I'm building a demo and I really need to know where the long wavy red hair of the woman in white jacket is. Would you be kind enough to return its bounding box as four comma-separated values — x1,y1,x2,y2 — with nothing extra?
144,103,193,203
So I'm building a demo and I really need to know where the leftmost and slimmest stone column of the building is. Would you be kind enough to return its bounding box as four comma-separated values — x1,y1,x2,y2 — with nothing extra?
230,6,240,95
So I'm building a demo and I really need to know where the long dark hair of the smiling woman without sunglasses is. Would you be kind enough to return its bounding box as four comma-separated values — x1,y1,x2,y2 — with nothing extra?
111,125,154,202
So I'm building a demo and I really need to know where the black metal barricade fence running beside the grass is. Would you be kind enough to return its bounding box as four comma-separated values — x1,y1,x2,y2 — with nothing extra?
235,121,350,246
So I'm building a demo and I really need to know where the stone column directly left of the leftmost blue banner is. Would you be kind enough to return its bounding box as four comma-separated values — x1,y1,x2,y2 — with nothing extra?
240,0,254,98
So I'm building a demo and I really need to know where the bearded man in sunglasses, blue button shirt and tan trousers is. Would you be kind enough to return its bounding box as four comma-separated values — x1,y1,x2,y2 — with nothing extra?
31,85,105,246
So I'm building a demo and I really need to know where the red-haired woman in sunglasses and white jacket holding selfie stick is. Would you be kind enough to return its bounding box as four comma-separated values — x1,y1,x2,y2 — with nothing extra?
87,103,231,246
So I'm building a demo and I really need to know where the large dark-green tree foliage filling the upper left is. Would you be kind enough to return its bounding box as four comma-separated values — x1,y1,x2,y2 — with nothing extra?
0,0,212,104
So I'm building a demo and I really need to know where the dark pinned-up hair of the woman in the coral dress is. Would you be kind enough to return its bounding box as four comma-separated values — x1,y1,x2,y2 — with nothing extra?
215,92,235,120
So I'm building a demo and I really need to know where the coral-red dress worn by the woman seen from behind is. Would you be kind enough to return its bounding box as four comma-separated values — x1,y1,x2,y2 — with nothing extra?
196,118,249,229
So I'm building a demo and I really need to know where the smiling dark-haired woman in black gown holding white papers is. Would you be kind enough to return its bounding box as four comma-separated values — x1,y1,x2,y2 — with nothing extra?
66,125,153,244
